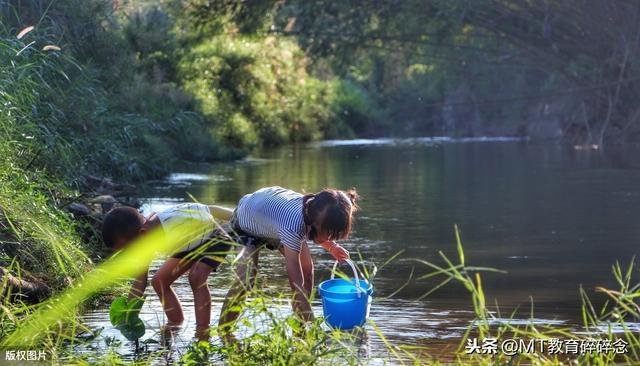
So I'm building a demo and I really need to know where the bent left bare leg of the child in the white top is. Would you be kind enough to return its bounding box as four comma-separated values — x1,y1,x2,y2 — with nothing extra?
151,258,193,326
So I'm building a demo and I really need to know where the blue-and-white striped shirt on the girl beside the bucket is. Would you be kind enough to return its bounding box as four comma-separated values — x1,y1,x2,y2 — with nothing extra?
236,186,307,252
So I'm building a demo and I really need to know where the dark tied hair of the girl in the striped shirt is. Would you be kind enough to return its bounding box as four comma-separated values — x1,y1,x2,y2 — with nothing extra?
302,188,359,240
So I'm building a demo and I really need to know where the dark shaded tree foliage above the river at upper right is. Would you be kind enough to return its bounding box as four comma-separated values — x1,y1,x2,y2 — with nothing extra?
276,0,640,143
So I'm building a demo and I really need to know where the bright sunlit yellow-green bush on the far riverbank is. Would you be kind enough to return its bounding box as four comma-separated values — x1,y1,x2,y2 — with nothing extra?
178,34,381,149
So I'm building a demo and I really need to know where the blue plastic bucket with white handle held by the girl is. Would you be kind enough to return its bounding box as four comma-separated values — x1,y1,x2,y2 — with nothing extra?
319,260,373,330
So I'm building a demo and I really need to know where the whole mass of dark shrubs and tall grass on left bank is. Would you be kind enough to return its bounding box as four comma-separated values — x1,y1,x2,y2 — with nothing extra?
0,0,228,304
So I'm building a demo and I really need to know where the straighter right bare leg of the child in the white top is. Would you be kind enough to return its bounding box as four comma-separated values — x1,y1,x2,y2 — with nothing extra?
189,262,213,341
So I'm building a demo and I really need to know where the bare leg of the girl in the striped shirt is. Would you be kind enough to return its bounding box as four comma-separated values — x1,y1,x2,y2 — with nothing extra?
218,245,259,341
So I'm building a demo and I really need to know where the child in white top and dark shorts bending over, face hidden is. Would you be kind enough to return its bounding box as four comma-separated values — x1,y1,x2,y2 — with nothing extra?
102,203,246,339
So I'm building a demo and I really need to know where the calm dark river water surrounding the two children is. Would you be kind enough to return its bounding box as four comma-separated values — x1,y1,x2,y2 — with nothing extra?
79,138,640,363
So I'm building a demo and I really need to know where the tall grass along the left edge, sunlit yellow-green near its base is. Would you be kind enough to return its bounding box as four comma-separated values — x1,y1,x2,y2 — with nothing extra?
0,27,91,288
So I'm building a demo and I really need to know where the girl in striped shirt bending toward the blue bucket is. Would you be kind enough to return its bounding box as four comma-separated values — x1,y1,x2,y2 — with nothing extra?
220,187,358,340
